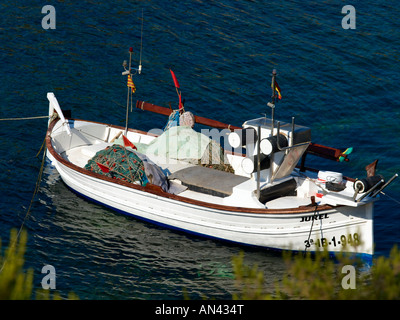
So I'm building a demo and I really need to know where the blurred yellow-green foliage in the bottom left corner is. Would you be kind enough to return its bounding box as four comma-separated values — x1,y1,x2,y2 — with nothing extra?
0,229,78,300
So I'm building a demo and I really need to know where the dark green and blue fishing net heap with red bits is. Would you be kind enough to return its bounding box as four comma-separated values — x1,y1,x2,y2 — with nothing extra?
85,144,169,191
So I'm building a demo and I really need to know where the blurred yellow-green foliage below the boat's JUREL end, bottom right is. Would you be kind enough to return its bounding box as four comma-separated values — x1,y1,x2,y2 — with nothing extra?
233,246,400,300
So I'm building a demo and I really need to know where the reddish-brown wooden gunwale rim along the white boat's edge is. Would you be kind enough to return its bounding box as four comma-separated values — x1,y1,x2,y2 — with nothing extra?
46,117,343,215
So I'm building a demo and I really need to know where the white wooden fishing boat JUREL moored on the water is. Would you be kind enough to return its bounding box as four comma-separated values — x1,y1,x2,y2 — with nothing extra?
46,58,394,257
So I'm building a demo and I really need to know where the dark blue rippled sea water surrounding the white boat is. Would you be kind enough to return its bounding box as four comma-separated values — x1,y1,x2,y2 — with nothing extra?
0,0,400,299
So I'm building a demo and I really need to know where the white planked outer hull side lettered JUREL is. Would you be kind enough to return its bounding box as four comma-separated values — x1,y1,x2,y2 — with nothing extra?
47,148,373,255
